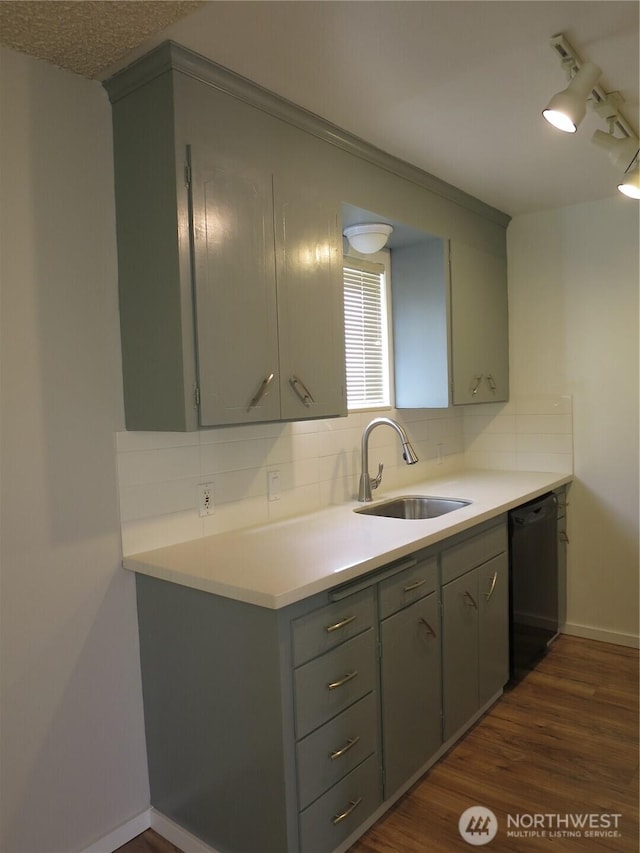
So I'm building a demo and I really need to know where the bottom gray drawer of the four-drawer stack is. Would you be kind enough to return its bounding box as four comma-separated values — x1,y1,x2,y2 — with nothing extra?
300,755,382,853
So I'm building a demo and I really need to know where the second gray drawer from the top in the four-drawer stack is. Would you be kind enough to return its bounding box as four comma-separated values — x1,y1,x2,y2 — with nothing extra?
293,628,376,740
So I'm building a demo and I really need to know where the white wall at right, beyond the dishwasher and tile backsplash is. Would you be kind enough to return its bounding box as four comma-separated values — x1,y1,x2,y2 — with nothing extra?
507,196,639,643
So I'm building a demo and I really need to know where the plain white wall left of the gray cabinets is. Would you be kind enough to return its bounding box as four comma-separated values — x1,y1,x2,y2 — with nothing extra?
0,49,149,853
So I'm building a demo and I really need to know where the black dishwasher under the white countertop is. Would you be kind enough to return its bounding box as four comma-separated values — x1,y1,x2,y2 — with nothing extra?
509,492,558,682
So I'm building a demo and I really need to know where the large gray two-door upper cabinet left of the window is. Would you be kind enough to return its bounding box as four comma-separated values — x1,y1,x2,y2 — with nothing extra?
107,45,346,430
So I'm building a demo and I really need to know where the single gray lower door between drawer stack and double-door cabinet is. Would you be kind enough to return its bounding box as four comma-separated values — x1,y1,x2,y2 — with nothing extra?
380,593,442,797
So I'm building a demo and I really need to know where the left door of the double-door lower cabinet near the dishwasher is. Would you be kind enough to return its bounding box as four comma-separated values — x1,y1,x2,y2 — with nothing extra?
442,570,478,741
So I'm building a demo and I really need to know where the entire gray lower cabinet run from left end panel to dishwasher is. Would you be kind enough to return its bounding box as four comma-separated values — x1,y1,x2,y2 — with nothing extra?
136,521,508,853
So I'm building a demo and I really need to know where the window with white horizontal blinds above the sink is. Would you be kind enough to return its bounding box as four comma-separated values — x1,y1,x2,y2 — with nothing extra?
343,253,391,411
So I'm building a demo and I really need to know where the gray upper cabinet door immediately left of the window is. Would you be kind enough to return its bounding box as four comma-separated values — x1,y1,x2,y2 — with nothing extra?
274,177,347,420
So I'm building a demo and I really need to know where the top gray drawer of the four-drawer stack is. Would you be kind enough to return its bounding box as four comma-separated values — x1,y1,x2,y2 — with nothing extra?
292,587,375,666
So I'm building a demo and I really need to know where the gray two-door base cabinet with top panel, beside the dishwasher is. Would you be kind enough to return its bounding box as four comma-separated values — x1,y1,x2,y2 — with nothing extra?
442,524,509,741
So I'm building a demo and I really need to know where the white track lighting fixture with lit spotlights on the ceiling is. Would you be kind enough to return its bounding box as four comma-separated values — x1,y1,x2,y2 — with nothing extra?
542,33,640,198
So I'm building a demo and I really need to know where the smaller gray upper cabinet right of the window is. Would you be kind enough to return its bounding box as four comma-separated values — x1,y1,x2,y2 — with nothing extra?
392,235,509,409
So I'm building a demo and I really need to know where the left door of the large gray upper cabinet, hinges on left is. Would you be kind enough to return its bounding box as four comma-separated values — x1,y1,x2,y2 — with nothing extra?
192,150,280,426
